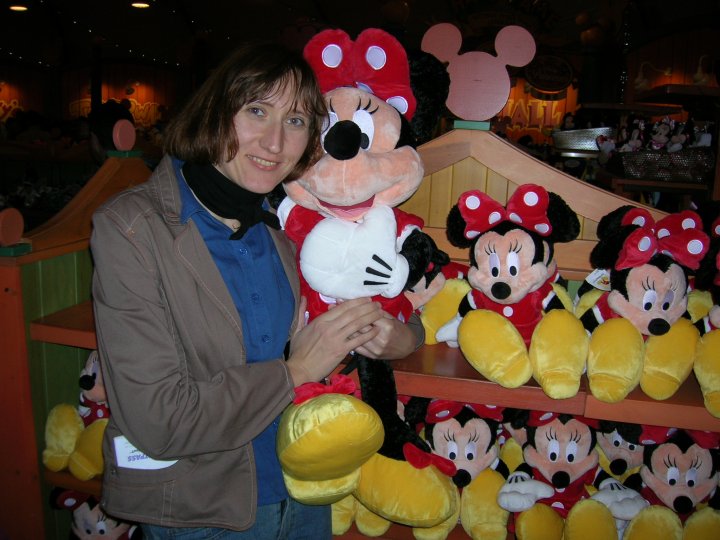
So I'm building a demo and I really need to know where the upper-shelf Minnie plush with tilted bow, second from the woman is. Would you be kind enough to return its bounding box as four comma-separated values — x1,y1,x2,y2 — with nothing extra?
576,206,709,402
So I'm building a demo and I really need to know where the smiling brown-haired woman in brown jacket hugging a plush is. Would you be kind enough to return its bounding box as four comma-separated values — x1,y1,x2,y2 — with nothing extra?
91,40,422,540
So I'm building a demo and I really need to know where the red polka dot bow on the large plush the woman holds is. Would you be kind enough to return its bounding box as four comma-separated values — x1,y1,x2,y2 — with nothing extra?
303,28,416,120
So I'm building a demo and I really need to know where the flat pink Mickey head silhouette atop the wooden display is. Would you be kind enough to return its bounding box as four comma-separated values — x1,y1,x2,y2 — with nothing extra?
420,23,535,120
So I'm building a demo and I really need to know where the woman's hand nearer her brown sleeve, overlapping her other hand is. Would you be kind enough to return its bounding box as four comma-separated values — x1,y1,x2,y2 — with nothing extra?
287,298,389,386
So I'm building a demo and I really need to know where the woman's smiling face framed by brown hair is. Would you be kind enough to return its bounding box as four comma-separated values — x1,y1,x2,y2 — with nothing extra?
215,82,310,193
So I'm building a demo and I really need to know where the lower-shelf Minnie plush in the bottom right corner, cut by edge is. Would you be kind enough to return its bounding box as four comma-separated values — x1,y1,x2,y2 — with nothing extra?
623,429,720,540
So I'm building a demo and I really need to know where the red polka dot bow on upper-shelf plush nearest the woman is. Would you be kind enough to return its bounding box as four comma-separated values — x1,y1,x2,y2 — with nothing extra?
458,184,552,240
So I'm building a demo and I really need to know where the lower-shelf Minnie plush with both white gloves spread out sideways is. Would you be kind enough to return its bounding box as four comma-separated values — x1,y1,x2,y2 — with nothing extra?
498,411,647,540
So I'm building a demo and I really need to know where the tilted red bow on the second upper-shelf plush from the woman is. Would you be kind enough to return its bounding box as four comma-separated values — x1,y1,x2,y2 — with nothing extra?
615,208,710,270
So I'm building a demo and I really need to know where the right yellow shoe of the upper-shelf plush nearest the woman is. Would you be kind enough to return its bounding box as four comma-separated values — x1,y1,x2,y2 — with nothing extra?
530,309,589,399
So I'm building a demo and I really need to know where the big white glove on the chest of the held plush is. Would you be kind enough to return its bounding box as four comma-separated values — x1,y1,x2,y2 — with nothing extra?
300,206,409,300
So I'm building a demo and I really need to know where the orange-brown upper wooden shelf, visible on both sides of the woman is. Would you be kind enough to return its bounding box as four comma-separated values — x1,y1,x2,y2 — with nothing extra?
36,301,720,432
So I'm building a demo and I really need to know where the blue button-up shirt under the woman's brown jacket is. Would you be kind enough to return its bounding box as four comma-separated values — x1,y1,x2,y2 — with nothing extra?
175,160,295,505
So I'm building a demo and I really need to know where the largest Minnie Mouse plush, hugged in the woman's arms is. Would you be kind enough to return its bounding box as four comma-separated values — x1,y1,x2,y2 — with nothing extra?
278,29,456,527
